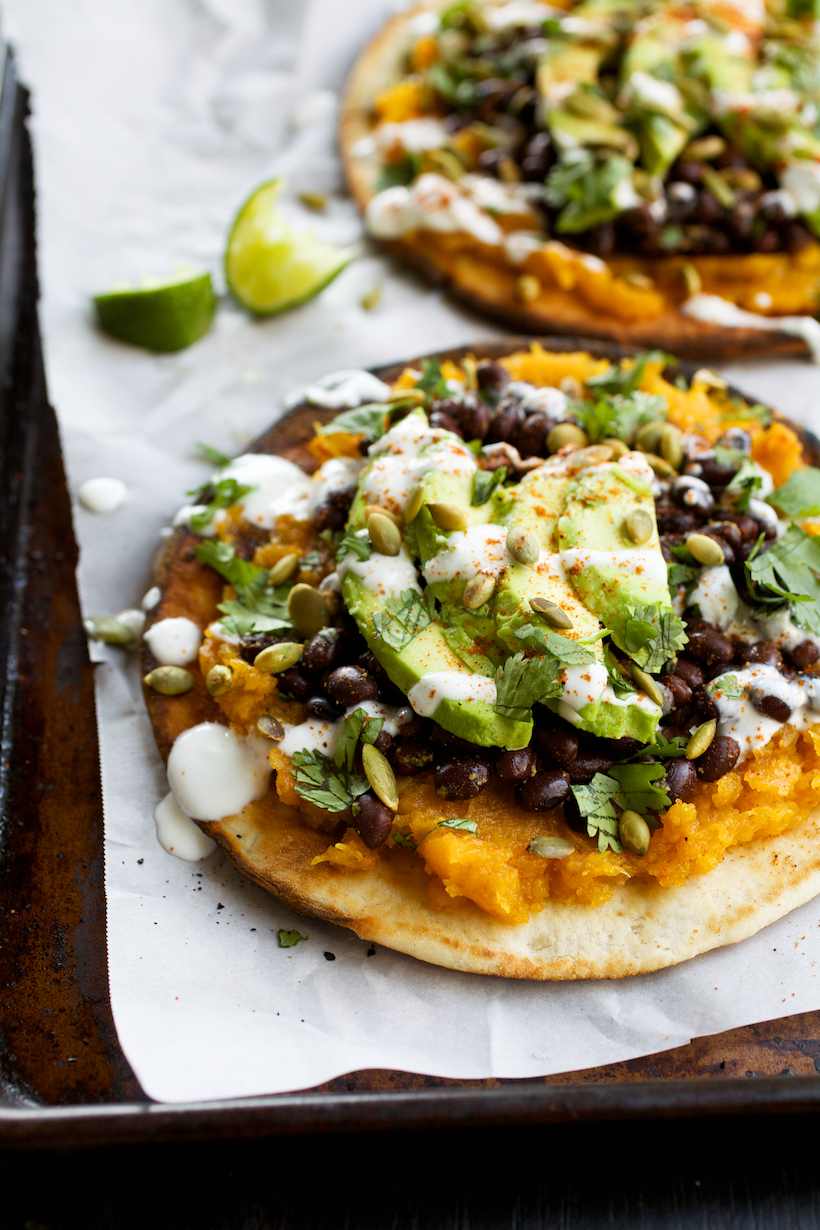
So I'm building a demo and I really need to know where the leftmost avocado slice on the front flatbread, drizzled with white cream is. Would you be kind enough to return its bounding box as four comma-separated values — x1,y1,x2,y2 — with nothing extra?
341,410,532,748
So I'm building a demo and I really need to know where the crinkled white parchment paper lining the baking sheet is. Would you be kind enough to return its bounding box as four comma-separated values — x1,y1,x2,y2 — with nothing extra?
5,0,820,1101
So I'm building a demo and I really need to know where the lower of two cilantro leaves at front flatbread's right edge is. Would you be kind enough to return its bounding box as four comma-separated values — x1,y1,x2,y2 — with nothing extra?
746,525,820,635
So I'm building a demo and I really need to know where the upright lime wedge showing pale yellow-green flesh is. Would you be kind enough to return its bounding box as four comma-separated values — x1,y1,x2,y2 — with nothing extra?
225,180,353,316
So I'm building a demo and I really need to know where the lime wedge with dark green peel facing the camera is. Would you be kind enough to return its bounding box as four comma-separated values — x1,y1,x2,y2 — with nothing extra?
93,273,216,352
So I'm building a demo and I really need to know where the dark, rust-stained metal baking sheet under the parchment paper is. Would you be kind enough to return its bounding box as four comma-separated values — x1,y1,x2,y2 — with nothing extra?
0,57,820,1148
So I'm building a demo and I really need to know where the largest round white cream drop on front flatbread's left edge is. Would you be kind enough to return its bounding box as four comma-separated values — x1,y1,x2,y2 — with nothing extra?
168,722,270,820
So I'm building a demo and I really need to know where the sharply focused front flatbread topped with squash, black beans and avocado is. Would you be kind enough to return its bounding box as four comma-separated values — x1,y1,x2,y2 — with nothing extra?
144,339,820,979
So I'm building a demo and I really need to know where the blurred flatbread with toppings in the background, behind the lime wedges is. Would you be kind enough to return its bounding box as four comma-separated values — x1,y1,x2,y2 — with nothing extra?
341,0,820,357
